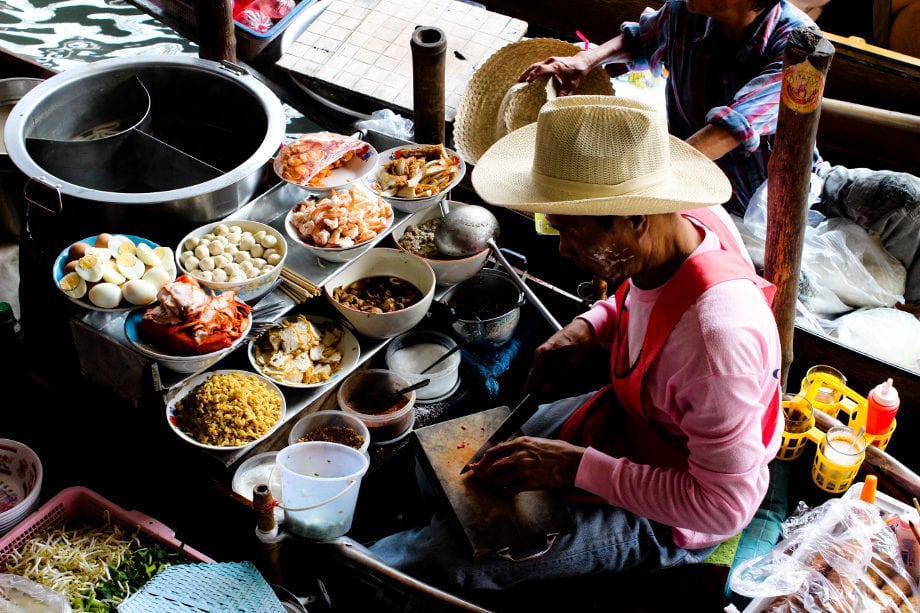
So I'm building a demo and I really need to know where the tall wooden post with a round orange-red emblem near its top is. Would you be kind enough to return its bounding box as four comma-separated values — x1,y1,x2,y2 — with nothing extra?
764,26,834,390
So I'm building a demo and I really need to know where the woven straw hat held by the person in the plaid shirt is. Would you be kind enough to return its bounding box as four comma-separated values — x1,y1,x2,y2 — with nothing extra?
453,38,614,164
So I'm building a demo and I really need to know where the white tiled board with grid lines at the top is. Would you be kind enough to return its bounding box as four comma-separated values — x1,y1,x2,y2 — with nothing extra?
276,0,527,122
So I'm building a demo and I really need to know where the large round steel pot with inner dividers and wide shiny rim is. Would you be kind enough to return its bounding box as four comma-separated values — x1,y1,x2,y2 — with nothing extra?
4,56,285,248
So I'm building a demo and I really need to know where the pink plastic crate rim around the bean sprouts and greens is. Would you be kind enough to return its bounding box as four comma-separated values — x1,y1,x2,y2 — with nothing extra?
0,486,214,571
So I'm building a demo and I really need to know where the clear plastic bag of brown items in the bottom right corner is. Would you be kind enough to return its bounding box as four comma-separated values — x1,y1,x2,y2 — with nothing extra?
729,498,918,613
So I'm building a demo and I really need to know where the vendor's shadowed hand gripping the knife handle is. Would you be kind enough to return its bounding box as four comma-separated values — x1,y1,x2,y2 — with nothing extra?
524,317,594,400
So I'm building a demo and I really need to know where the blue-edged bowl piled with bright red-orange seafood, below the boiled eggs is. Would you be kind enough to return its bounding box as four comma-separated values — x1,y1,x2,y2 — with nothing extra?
125,275,252,373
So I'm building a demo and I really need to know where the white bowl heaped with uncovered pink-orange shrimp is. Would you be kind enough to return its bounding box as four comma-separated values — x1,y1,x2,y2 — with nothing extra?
284,185,394,262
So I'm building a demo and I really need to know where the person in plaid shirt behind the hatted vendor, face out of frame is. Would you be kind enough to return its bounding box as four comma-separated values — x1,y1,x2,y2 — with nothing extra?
519,0,920,317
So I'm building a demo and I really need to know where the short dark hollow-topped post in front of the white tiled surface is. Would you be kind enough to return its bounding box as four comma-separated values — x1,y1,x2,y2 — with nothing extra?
410,26,447,144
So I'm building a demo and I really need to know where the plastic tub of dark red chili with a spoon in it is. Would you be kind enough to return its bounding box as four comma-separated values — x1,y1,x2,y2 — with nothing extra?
337,368,415,445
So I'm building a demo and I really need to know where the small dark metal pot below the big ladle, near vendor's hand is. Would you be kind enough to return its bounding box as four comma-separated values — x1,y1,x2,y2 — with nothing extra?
439,268,525,351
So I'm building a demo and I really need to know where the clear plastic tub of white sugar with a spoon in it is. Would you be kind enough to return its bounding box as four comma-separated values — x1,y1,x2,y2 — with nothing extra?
385,330,461,403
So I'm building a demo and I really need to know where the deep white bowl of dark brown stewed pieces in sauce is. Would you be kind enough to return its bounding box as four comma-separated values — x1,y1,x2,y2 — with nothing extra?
324,247,436,339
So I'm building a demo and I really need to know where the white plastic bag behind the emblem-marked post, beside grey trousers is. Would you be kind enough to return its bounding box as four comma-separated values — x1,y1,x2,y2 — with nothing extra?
735,175,907,317
